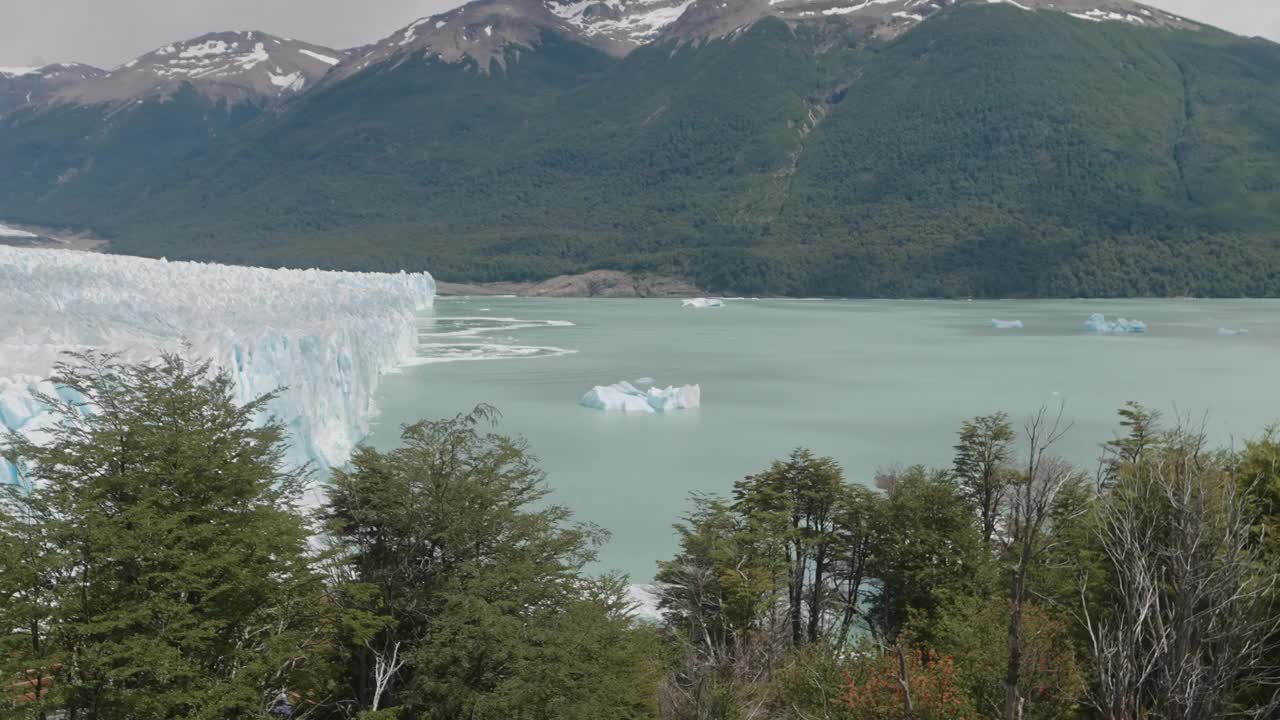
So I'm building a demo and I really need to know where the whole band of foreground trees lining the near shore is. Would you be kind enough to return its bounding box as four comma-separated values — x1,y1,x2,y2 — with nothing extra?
0,355,1280,720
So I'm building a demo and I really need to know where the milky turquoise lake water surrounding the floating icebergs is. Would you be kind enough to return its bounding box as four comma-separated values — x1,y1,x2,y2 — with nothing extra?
369,299,1280,582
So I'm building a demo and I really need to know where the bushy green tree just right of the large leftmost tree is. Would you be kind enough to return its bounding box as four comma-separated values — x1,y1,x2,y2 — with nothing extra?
324,406,657,720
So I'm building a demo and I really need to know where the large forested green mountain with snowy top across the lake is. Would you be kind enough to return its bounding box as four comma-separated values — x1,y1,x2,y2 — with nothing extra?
0,0,1280,296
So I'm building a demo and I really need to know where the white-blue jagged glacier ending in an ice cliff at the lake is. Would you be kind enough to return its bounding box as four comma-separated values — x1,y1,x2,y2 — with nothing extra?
0,246,435,482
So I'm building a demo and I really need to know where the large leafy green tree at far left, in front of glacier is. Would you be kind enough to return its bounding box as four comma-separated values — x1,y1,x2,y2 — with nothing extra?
0,355,329,720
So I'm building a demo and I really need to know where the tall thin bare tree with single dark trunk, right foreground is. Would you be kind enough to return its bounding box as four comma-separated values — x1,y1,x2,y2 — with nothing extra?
1002,406,1080,720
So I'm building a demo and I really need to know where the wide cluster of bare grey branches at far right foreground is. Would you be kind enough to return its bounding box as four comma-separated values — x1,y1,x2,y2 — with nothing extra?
1082,422,1280,720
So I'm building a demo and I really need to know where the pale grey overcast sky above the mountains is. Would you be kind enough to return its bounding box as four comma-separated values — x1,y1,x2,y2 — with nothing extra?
0,0,1280,68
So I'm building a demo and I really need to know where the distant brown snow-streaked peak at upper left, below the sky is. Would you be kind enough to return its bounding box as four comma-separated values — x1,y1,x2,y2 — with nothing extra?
46,31,344,104
